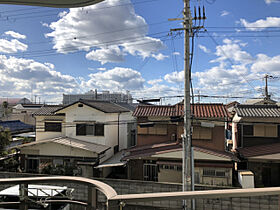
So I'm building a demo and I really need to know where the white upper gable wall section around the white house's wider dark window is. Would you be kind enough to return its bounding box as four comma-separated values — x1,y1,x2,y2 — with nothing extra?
57,103,134,162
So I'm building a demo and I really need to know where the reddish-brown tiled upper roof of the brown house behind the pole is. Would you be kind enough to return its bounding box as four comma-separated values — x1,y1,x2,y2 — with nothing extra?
133,103,230,118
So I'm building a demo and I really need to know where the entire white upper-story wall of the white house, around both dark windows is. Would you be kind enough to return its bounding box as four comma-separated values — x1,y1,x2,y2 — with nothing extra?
36,103,134,163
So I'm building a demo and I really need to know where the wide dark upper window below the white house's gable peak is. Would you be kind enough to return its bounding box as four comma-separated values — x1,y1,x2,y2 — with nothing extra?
76,124,104,136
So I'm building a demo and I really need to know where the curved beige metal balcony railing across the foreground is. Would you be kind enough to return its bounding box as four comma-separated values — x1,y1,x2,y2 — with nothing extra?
0,176,280,210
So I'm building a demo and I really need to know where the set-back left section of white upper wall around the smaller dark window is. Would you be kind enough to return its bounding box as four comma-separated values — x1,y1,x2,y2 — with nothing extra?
35,116,65,141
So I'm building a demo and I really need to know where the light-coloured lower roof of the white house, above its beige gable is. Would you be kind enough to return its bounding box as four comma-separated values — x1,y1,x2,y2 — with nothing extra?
17,137,110,154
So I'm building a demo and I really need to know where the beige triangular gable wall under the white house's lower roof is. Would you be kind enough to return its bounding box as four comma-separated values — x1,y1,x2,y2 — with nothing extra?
21,142,97,158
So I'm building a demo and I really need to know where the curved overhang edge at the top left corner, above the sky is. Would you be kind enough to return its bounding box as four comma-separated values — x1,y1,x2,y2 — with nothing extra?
0,0,104,8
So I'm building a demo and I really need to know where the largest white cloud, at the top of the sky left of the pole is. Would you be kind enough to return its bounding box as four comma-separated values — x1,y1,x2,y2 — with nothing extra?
46,0,166,64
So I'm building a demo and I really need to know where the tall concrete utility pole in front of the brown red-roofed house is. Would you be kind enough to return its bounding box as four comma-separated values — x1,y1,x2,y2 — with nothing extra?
169,0,206,210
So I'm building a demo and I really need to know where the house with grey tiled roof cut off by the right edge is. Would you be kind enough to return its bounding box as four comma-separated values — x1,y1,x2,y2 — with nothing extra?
232,104,280,187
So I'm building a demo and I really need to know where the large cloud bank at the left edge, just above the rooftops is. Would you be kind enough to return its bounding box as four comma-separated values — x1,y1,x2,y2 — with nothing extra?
0,55,79,102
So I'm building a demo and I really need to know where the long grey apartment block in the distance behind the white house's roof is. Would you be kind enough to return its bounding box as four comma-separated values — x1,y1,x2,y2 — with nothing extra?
62,89,133,105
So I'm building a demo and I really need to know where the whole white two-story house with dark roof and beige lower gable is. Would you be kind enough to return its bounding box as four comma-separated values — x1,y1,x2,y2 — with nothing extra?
19,100,135,176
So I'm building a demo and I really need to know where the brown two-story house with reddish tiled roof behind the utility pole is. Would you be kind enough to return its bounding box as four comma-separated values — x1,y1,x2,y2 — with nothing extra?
123,103,237,186
